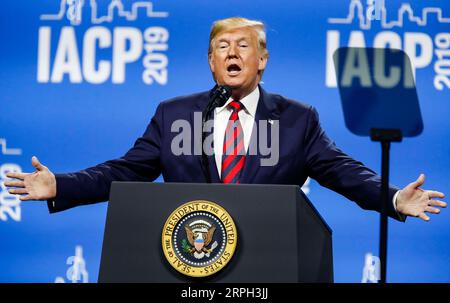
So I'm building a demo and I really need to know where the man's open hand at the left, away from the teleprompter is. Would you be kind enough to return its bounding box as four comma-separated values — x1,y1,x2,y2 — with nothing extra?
5,156,56,201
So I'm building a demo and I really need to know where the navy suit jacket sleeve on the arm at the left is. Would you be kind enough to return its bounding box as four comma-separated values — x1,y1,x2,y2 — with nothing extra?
47,103,163,213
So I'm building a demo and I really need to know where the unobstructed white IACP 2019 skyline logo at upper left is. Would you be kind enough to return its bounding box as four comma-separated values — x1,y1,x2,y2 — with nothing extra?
37,0,169,85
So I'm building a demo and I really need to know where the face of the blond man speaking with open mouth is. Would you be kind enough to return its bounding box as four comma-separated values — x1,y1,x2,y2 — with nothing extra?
209,28,267,98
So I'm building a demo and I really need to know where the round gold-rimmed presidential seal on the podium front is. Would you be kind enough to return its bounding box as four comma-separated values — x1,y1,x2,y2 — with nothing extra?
162,200,237,277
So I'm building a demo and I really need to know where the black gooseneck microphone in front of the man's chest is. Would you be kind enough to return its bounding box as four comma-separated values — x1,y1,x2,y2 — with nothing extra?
201,85,231,183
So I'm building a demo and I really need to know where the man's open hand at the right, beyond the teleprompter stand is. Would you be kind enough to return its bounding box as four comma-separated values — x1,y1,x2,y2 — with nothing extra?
397,174,447,221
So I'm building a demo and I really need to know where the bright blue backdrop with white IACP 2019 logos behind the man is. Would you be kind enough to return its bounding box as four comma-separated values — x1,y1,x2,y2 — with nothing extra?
0,0,450,282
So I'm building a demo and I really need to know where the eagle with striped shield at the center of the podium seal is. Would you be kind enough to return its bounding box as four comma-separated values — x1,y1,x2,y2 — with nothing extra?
182,220,218,259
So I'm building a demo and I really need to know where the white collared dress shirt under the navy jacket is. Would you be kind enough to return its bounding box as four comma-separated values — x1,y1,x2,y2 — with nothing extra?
214,86,260,177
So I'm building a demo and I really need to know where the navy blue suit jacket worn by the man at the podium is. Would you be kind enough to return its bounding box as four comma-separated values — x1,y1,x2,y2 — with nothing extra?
48,87,404,220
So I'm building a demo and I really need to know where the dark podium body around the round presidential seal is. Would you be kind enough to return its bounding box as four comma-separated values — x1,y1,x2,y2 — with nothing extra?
98,182,333,282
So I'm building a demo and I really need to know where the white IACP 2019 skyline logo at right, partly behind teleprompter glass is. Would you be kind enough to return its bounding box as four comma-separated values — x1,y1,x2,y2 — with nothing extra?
326,0,450,91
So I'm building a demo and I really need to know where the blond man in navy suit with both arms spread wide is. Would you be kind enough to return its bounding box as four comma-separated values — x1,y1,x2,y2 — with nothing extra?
5,18,446,221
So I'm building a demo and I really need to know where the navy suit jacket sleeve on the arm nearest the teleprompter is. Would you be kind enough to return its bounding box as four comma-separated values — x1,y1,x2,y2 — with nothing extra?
304,107,406,221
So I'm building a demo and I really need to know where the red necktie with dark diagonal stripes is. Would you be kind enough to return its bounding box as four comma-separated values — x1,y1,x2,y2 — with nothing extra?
221,101,245,183
